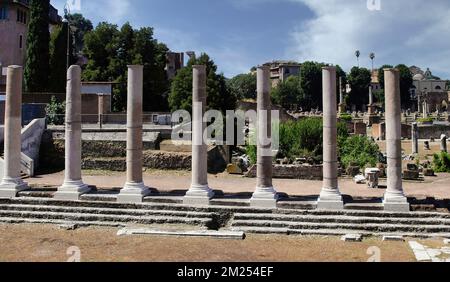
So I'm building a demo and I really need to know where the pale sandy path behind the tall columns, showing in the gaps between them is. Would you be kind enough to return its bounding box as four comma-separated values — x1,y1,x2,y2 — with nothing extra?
26,170,450,199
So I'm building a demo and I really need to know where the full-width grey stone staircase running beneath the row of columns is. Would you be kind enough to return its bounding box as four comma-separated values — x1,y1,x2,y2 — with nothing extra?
0,195,450,238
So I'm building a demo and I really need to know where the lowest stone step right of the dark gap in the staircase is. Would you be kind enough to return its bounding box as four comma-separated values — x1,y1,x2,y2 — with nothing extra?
231,226,450,238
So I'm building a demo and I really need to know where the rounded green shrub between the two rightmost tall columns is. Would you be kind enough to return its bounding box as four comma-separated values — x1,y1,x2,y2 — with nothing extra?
339,136,380,168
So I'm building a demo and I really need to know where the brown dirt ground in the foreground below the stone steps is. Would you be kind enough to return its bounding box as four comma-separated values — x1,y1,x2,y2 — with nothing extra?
0,224,415,262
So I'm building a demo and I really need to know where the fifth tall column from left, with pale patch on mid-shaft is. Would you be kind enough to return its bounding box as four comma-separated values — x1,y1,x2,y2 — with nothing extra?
250,66,278,208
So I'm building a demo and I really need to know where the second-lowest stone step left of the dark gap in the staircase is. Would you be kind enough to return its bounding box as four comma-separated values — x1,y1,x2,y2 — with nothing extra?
0,205,214,218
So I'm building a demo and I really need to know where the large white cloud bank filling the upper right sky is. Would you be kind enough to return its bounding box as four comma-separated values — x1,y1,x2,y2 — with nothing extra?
286,0,450,77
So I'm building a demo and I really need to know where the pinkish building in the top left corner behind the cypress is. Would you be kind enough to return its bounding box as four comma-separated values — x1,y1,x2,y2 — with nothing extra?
0,0,62,92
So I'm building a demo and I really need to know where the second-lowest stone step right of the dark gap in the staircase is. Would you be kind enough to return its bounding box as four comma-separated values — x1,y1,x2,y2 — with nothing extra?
231,220,450,233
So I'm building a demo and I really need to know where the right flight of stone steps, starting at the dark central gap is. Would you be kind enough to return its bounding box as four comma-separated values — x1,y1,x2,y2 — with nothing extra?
230,210,450,237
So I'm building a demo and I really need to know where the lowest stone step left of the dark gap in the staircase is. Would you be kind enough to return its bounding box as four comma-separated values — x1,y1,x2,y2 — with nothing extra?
0,210,216,228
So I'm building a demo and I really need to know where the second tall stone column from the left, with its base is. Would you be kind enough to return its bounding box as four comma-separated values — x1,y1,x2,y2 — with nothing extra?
54,66,90,201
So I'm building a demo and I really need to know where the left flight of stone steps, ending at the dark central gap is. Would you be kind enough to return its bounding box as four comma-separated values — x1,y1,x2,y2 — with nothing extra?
0,198,217,229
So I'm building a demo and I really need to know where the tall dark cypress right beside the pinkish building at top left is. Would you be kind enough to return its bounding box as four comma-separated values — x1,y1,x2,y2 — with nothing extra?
24,0,50,92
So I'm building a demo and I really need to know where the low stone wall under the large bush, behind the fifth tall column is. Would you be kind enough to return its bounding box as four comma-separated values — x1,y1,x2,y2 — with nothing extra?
245,165,323,180
